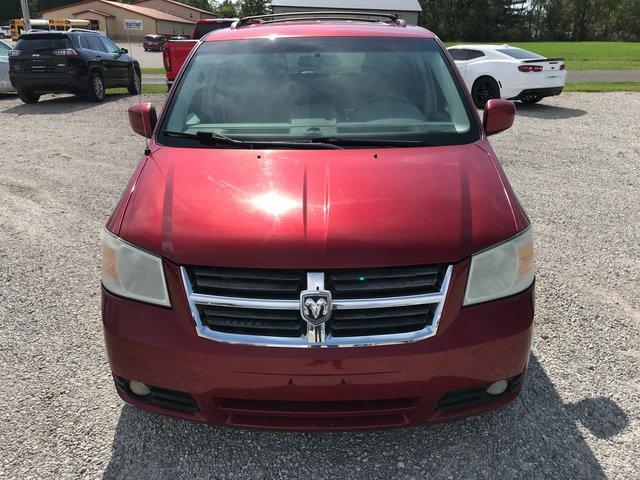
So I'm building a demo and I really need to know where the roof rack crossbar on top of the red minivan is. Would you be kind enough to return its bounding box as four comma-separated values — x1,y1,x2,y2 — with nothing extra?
231,10,407,28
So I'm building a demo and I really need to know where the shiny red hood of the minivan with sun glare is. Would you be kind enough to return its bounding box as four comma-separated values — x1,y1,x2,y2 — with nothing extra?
119,144,518,268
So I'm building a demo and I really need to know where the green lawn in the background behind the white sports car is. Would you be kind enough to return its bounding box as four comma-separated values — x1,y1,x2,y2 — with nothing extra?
447,42,640,70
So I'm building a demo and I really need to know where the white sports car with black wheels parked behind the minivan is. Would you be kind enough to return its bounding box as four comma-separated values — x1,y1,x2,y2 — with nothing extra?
448,45,567,108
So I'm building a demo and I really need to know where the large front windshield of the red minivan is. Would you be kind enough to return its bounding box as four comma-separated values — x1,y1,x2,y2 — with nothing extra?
158,37,479,146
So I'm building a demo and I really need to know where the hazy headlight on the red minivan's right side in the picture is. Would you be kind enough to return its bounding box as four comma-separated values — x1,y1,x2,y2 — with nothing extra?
464,228,535,305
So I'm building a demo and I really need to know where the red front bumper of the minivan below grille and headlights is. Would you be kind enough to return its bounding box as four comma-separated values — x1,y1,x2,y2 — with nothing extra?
102,262,534,430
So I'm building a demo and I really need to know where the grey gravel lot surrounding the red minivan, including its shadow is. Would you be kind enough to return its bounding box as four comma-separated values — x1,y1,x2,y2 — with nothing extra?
0,93,640,480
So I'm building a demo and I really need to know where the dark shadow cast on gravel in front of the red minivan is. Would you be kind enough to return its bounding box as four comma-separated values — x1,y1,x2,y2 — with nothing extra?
104,356,628,480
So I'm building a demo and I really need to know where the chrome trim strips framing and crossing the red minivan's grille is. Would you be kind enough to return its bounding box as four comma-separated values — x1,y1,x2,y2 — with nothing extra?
180,265,453,348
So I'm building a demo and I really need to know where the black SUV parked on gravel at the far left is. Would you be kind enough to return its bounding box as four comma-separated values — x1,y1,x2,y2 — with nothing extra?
9,30,141,103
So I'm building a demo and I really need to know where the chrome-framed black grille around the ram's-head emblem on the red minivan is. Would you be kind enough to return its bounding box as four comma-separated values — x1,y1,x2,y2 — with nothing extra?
181,265,452,347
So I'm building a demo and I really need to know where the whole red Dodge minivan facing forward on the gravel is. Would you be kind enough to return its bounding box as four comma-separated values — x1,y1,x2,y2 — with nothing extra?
102,12,534,430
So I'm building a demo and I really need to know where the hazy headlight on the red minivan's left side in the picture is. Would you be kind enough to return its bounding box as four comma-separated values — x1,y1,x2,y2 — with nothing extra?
102,230,171,307
